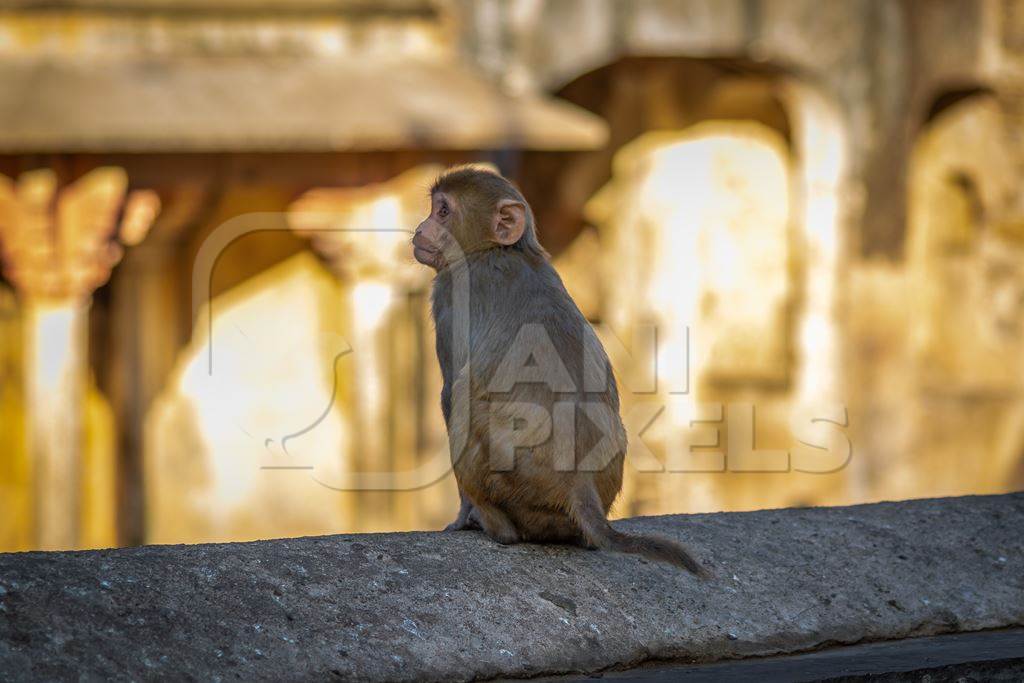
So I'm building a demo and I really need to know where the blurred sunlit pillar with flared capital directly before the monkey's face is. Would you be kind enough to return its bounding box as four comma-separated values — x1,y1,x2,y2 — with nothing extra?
289,166,454,531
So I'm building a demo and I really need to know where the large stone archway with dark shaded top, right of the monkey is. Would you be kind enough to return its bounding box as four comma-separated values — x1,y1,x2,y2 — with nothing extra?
542,58,854,514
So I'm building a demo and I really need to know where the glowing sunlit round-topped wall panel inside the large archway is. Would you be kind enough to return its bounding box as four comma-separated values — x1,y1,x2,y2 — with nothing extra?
586,120,793,514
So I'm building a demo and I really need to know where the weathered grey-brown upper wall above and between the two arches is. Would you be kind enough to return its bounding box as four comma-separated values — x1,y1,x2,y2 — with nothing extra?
454,0,1021,258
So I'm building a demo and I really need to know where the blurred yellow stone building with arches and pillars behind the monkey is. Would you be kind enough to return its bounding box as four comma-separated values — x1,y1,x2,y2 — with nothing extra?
0,0,1024,550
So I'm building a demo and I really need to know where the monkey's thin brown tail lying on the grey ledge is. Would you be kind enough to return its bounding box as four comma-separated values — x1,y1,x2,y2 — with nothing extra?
570,485,711,579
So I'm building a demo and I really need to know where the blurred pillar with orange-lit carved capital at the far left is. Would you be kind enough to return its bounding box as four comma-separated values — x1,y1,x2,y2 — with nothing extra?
0,168,159,550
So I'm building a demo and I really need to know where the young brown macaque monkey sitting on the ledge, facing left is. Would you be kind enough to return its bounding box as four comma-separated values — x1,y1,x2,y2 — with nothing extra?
413,167,707,575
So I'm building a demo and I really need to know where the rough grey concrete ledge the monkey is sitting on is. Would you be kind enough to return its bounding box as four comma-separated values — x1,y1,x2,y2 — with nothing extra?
0,494,1024,680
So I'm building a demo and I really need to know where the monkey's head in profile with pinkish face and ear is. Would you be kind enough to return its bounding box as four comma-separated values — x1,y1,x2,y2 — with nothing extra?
413,167,547,270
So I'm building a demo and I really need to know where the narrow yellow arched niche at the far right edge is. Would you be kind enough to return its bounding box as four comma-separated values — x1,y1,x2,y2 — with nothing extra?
897,90,1024,497
